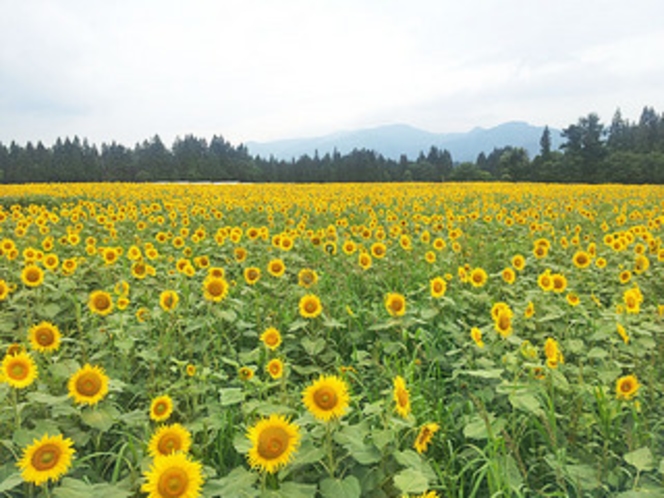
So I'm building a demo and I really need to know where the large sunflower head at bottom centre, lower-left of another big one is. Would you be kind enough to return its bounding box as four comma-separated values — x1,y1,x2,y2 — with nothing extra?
247,414,300,474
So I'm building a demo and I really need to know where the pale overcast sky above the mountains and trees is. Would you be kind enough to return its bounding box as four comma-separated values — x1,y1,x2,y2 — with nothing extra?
0,0,664,146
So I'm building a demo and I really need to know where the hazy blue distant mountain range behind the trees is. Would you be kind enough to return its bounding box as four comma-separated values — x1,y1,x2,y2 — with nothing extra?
245,121,564,162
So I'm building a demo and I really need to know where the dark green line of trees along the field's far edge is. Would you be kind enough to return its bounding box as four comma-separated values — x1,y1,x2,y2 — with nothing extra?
0,106,664,184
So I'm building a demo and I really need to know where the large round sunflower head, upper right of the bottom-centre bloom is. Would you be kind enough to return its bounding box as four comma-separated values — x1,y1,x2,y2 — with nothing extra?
302,375,350,422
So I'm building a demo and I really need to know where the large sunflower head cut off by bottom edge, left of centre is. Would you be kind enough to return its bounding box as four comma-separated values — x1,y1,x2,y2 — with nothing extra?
141,452,203,498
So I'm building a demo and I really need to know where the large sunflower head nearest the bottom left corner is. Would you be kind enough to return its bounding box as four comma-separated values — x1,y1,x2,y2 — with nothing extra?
16,434,75,486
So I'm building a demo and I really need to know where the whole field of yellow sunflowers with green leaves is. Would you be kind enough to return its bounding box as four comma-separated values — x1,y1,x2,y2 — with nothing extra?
0,183,664,498
